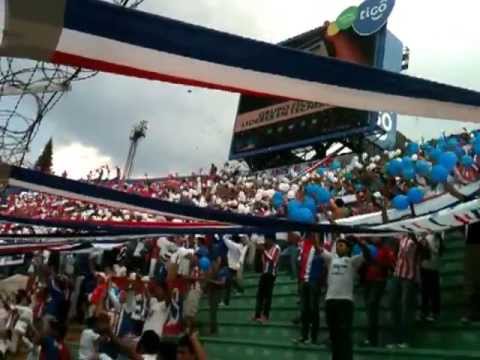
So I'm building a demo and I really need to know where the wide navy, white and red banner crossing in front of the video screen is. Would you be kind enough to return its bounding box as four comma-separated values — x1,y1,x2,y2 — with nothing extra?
0,0,480,122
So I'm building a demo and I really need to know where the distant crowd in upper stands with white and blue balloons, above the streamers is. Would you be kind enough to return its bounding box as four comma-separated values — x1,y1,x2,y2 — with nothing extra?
0,132,480,233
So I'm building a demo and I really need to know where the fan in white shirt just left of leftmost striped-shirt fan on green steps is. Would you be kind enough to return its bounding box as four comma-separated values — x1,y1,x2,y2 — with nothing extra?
223,235,246,306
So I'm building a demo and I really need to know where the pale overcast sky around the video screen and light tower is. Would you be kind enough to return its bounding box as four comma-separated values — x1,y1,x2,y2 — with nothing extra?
25,0,480,177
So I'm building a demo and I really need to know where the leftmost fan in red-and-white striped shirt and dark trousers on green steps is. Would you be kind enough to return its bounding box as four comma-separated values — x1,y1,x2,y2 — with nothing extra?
253,234,280,323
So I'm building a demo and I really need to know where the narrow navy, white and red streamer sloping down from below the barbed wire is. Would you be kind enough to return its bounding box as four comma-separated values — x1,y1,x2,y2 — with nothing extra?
0,164,392,234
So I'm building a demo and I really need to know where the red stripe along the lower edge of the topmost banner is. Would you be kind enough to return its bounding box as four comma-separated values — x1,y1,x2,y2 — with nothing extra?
50,51,288,100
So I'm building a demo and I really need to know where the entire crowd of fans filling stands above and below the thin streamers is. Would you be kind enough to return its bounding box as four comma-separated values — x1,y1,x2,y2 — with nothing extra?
0,128,480,360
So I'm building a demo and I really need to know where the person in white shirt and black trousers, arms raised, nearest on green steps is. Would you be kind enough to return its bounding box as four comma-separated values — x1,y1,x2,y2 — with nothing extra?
319,236,370,360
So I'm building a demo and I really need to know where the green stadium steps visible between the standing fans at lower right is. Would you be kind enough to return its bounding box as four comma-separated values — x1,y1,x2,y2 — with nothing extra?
199,234,480,360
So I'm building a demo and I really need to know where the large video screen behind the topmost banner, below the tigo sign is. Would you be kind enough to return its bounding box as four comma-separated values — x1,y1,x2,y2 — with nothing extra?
230,27,386,159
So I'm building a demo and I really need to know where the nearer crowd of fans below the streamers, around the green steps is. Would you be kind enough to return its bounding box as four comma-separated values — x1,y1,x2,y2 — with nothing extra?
0,225,472,360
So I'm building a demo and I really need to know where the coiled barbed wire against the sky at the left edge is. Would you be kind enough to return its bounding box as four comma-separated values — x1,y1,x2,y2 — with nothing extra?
0,0,145,166
